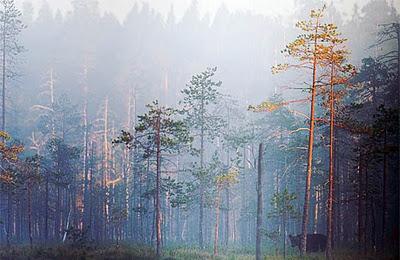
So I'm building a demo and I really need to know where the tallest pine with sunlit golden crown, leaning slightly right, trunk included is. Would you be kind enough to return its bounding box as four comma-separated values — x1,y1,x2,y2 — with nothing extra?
272,6,354,255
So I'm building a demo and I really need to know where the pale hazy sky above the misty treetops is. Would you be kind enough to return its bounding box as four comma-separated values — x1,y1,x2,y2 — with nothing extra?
16,0,400,21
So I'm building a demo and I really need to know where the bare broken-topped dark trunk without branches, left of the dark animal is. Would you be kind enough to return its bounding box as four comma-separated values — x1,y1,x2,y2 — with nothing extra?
256,143,263,260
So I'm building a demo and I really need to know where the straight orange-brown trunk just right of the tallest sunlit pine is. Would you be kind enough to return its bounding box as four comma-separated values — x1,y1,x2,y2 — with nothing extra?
326,61,335,259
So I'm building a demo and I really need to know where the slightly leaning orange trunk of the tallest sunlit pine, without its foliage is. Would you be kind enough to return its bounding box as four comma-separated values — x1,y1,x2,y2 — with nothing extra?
300,18,319,255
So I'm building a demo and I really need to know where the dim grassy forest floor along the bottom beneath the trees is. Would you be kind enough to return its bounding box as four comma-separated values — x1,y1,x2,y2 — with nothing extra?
0,246,397,260
